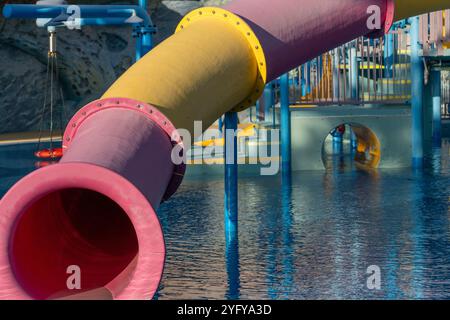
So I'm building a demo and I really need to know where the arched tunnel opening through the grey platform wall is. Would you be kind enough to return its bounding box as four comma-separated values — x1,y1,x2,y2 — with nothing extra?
322,123,381,172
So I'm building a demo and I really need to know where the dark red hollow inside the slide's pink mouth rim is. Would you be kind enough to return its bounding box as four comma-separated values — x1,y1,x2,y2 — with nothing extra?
9,188,139,300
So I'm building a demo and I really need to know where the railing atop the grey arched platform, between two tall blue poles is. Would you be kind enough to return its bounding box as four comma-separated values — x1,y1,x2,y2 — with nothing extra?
290,30,411,105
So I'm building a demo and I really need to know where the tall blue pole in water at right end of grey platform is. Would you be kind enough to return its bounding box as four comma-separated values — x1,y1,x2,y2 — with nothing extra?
411,17,424,168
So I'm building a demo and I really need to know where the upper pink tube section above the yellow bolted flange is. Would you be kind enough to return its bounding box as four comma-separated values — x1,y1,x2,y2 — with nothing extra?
225,0,394,81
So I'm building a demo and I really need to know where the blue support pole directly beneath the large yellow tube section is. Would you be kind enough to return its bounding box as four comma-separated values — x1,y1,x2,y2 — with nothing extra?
224,112,238,239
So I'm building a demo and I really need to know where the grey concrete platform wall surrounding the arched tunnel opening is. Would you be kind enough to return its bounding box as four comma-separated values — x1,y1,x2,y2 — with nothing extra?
292,105,411,170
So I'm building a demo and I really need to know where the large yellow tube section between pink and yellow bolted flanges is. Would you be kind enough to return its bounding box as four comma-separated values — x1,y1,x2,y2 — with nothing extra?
103,17,258,134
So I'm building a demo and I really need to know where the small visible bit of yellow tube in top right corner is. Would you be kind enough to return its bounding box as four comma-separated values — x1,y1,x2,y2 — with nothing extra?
395,0,450,21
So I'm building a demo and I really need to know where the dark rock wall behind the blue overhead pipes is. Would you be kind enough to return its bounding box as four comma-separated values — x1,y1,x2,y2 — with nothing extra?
0,0,226,133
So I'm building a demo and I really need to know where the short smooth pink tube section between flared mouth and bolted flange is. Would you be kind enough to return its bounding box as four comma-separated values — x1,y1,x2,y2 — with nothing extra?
60,100,174,210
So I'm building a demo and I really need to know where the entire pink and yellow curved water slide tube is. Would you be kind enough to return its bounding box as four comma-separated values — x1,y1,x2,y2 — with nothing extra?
0,0,448,299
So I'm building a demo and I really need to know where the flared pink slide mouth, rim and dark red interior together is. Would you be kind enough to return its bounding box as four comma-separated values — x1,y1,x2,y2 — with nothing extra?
0,163,165,299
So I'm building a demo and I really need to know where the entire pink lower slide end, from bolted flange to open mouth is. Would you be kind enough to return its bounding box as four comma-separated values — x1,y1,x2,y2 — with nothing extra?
0,99,184,299
